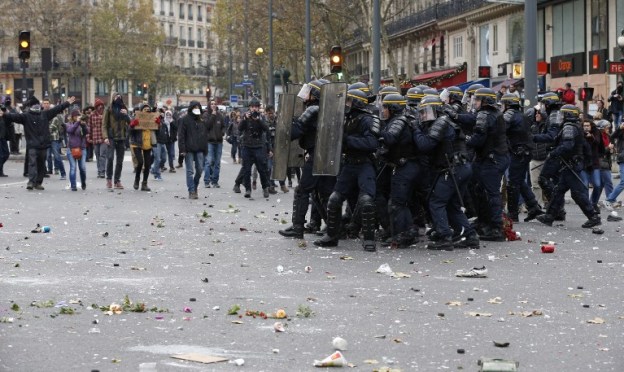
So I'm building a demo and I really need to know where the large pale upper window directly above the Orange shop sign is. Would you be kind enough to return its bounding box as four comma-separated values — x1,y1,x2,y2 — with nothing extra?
552,0,585,56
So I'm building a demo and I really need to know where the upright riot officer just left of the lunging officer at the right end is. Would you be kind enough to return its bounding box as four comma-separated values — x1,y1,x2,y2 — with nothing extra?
500,93,544,222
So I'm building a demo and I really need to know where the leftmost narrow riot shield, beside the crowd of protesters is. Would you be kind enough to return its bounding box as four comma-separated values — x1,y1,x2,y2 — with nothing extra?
271,93,298,180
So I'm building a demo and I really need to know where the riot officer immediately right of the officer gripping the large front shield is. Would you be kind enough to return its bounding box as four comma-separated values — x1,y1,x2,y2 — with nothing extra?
381,93,423,247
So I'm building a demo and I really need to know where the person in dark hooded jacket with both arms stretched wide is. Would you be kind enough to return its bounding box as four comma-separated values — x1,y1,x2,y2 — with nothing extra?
4,96,76,190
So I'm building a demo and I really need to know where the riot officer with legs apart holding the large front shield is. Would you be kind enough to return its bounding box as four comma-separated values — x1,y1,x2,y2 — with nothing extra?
314,89,379,252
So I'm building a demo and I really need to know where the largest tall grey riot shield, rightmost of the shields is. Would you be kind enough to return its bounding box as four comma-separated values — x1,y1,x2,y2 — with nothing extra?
312,82,347,176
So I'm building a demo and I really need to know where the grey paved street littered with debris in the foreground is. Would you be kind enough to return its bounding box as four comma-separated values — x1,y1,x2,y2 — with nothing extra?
0,149,624,371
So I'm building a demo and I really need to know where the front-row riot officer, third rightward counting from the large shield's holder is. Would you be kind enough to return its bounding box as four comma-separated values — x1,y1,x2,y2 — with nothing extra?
414,96,479,251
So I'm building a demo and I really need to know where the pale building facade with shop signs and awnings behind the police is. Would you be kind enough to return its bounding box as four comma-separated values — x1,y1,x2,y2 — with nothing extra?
343,0,624,98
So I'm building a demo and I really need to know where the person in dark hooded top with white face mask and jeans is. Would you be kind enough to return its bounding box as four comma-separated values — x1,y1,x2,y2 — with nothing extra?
178,101,208,199
